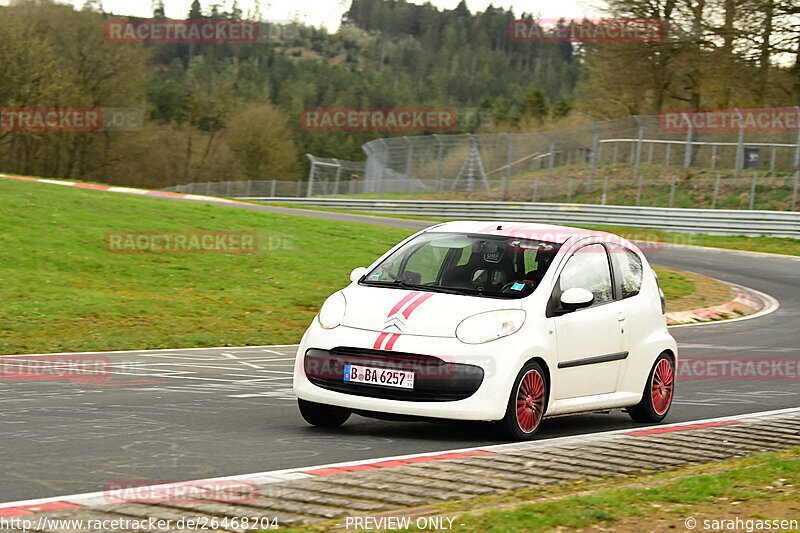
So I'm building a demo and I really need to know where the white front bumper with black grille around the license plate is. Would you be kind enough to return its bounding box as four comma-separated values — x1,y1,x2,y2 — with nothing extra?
294,320,525,420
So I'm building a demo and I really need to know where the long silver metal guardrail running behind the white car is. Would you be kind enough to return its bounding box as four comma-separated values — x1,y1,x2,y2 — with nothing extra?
237,197,800,239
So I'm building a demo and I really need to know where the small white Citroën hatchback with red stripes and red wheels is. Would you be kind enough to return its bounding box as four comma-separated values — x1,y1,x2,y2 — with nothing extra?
294,222,678,439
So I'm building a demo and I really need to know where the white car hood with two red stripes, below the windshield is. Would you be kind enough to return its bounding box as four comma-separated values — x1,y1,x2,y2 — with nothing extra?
342,283,521,337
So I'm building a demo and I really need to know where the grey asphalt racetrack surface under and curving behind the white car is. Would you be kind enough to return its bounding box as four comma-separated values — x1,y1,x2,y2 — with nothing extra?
0,206,800,502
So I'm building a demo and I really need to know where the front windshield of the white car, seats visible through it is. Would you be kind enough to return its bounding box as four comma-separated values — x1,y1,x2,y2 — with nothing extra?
361,233,559,299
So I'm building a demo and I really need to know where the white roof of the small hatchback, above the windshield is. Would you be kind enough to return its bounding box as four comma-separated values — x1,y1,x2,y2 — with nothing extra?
427,220,624,244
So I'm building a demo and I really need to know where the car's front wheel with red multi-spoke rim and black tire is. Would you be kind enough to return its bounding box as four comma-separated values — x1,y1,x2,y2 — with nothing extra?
501,362,549,440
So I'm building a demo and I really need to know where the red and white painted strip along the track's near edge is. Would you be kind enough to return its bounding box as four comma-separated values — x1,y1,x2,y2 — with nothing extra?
0,407,800,516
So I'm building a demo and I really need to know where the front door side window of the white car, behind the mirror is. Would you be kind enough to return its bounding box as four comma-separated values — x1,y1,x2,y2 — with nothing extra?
558,244,614,305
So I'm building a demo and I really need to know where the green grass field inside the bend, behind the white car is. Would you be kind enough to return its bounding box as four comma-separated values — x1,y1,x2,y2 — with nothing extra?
0,179,752,354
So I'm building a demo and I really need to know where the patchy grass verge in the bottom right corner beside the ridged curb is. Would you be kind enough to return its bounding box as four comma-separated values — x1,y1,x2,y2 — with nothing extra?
276,448,800,533
